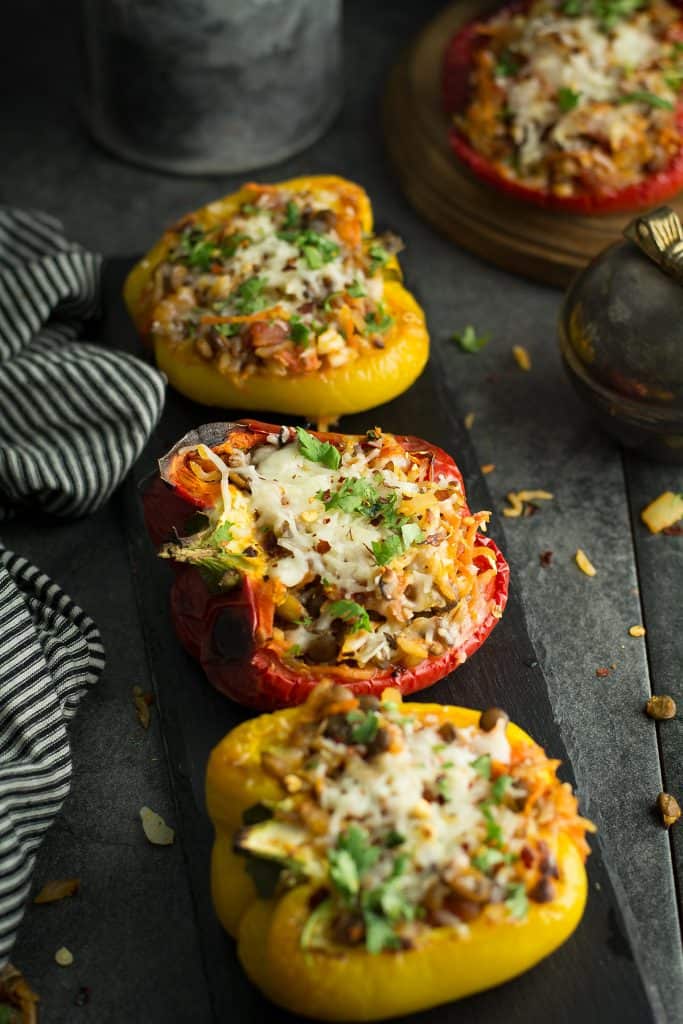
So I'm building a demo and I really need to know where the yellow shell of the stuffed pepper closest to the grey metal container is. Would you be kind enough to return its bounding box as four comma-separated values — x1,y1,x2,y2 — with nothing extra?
124,175,429,421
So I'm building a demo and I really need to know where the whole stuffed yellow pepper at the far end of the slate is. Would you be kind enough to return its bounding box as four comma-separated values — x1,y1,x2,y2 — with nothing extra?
124,175,429,421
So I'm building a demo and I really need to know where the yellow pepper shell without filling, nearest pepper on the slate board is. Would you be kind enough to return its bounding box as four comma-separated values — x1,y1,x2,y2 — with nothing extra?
207,703,587,1021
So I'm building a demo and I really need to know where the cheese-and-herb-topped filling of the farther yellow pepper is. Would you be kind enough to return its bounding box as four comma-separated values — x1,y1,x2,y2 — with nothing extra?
144,185,400,378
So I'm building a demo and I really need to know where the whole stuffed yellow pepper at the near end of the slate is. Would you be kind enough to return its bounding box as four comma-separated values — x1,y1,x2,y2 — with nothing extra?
207,684,593,1020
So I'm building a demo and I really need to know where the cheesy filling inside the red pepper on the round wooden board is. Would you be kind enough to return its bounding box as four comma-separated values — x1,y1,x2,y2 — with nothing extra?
459,0,681,195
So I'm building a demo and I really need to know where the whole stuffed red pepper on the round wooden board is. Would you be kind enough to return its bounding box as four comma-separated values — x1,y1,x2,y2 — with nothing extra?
443,0,683,214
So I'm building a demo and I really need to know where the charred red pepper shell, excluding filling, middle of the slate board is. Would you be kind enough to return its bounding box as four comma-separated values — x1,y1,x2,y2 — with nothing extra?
143,420,509,710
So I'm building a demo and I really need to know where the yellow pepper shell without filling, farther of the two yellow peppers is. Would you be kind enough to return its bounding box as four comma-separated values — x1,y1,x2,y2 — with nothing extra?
124,175,429,419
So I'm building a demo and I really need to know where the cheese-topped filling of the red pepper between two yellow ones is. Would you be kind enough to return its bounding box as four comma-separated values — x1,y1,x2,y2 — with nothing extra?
162,427,502,672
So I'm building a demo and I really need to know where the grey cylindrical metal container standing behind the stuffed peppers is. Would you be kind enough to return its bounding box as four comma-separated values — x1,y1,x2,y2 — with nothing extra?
82,0,342,174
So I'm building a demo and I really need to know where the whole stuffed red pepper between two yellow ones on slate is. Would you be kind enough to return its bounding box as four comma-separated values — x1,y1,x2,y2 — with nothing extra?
144,420,509,709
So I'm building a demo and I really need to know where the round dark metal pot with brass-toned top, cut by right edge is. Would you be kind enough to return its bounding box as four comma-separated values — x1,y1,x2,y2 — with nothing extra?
559,207,683,463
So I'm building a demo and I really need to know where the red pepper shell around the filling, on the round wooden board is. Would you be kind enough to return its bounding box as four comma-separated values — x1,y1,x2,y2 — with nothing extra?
441,0,683,214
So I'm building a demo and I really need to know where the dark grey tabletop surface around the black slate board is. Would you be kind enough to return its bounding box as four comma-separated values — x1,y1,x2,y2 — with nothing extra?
0,0,683,1024
